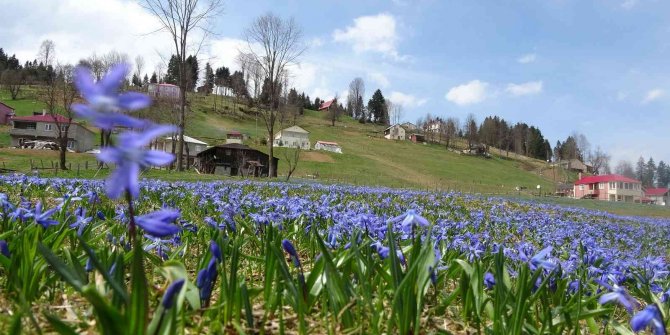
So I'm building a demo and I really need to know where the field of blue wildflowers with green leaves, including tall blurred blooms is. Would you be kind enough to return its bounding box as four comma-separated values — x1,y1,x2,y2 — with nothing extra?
0,66,670,334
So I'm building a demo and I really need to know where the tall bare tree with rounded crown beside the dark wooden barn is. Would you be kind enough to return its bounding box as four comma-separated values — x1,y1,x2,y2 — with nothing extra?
245,13,305,177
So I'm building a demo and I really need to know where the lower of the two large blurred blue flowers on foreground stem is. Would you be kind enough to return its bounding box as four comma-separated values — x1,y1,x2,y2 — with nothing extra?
98,126,176,199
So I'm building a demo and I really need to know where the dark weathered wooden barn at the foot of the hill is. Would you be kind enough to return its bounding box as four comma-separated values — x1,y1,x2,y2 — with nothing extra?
197,143,279,177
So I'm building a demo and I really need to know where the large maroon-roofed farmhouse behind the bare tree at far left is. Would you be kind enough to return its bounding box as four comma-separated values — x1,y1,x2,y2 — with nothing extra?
9,115,95,152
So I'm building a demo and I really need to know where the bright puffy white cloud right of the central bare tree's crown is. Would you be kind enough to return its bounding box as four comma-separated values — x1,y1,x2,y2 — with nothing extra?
333,13,405,60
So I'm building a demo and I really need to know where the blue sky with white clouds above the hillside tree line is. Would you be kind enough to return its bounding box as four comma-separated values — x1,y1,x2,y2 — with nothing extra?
0,0,670,166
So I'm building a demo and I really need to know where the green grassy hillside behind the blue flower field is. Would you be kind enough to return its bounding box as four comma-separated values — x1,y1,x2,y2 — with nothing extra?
0,88,670,216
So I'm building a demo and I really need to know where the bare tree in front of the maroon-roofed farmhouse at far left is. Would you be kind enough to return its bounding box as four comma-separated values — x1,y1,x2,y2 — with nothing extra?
40,65,77,170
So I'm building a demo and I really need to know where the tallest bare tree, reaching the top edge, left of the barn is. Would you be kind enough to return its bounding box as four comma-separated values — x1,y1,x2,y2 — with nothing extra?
142,0,223,171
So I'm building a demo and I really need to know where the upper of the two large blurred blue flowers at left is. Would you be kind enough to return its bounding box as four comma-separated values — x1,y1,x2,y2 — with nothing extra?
72,64,151,130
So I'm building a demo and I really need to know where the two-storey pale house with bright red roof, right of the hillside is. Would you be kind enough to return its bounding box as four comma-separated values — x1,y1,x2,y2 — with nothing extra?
573,173,644,202
